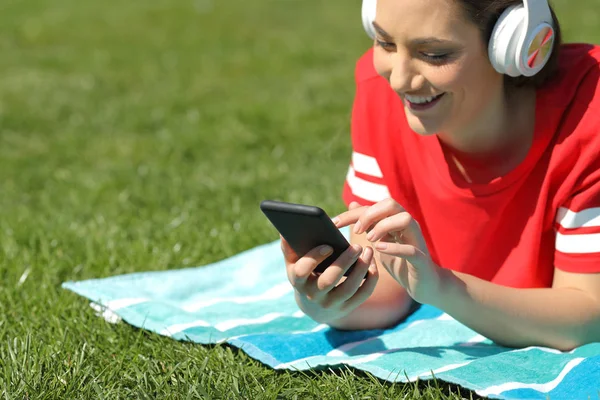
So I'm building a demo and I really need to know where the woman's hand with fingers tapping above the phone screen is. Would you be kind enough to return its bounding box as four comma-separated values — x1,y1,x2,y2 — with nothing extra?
333,199,444,304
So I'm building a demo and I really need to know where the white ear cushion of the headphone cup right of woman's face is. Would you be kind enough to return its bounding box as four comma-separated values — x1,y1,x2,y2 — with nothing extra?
488,5,527,77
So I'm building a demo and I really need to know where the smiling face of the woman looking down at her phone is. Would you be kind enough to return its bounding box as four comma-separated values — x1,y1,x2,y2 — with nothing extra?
374,0,504,134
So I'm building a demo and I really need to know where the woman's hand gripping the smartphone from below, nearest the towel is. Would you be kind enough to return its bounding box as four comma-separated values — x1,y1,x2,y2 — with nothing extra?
281,237,379,323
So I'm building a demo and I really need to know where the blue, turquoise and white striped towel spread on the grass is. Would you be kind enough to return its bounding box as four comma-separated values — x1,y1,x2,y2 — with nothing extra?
63,230,600,399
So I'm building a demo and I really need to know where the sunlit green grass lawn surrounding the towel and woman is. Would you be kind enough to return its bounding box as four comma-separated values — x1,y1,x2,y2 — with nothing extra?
0,0,600,399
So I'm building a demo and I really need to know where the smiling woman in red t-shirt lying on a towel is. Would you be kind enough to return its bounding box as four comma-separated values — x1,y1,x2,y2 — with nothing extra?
282,0,600,350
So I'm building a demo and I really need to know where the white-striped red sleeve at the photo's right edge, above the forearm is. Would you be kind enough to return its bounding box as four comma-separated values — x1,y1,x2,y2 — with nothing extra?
554,170,600,273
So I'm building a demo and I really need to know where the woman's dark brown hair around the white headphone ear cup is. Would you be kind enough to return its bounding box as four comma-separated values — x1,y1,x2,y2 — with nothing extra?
456,0,562,88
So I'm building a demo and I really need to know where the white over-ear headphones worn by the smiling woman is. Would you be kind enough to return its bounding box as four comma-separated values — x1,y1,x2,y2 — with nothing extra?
362,0,555,77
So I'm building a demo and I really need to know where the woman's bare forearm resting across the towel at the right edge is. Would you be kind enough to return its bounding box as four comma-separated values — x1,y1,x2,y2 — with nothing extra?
432,270,600,350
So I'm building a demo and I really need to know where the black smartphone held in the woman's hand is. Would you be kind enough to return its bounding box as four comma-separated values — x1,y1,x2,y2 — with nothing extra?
260,200,354,276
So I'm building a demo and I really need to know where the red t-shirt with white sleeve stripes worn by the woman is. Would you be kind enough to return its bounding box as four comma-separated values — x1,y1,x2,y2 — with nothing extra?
343,44,600,287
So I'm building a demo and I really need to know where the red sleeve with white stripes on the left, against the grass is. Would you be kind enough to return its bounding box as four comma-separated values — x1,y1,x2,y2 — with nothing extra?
342,54,390,206
